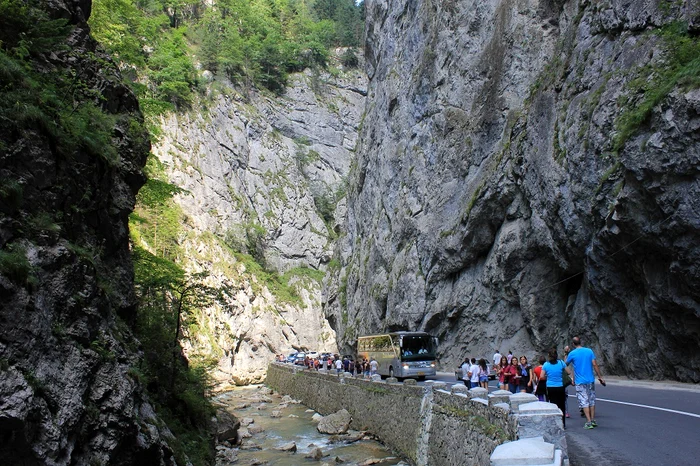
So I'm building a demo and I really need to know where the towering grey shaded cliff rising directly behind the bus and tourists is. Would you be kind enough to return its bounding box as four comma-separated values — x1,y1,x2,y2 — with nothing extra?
325,0,700,382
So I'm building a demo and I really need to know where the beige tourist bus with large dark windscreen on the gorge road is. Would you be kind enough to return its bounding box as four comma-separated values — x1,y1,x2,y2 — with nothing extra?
357,332,437,380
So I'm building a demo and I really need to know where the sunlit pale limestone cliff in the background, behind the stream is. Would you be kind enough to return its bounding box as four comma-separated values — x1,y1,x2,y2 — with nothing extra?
153,59,366,384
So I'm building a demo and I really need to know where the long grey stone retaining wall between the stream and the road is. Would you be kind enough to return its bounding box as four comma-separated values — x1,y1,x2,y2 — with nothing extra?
267,363,566,466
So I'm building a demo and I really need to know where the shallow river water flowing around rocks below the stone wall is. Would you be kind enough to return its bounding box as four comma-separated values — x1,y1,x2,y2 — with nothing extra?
214,386,407,466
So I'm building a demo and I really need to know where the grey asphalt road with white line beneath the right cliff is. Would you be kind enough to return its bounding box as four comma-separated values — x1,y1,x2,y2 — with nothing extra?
426,372,700,466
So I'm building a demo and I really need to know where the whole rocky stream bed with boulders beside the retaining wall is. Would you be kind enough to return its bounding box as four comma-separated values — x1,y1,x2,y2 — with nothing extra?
214,385,407,466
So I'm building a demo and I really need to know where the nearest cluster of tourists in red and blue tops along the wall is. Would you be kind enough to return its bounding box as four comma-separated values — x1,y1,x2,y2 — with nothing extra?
490,337,605,429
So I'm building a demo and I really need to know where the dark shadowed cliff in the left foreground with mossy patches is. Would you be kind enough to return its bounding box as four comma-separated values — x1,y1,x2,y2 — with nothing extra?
0,0,174,465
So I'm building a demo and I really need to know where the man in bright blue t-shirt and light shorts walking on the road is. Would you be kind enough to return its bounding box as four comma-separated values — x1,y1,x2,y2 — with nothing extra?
566,337,605,429
